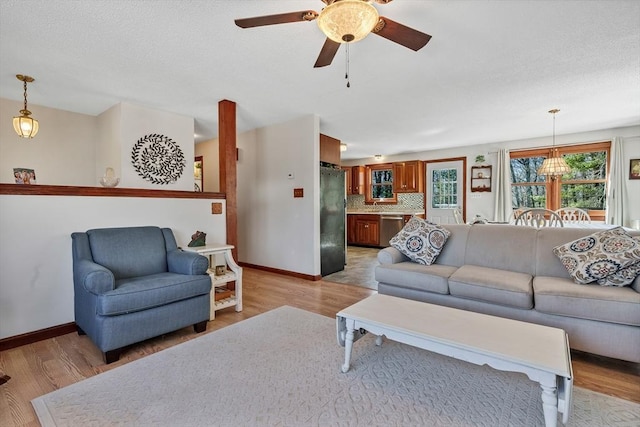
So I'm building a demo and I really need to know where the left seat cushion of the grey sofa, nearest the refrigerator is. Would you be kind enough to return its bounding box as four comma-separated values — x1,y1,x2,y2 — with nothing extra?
375,261,457,295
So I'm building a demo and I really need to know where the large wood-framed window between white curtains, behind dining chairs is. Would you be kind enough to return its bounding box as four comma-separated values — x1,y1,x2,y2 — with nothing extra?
511,142,611,220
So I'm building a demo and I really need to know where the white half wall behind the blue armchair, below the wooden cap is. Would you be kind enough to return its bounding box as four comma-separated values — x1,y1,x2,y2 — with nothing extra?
0,195,227,338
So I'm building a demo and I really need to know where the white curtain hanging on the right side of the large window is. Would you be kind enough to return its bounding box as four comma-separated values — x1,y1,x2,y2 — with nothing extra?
605,137,629,225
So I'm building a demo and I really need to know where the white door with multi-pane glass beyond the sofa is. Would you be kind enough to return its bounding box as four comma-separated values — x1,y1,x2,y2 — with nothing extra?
425,157,467,224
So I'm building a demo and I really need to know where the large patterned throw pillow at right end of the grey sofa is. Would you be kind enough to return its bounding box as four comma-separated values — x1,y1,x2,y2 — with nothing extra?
553,227,640,286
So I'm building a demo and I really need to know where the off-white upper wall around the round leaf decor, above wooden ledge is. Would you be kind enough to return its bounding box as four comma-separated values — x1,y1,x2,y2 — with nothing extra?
0,98,194,191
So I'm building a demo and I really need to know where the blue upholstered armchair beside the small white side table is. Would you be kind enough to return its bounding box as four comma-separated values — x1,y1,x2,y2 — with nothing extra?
71,227,211,363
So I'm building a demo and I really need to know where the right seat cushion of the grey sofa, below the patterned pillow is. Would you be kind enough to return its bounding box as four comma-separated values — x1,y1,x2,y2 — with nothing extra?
533,276,640,326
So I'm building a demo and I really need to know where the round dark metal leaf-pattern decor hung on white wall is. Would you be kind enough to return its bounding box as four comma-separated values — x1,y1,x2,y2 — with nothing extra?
131,133,186,185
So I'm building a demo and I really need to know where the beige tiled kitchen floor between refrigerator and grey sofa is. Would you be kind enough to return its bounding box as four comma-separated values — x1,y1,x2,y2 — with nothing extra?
322,246,380,291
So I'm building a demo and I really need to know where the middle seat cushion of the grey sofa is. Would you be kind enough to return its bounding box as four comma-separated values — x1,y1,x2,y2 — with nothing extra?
449,265,533,309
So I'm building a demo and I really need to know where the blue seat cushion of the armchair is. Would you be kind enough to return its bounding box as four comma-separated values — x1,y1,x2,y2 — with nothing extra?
96,273,211,316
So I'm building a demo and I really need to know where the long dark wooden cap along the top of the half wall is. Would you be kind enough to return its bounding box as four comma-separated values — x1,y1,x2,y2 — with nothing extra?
0,184,226,199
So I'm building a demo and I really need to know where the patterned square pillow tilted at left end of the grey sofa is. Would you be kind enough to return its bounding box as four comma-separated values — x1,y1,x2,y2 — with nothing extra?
389,216,451,265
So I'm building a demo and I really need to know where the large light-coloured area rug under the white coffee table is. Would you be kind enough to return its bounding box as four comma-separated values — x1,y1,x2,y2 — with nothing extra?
32,307,640,427
